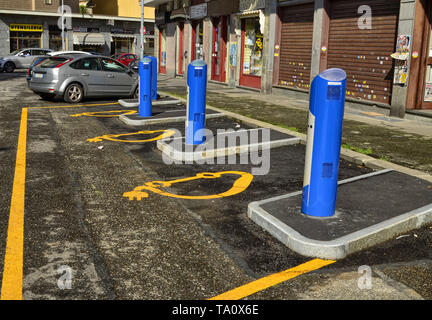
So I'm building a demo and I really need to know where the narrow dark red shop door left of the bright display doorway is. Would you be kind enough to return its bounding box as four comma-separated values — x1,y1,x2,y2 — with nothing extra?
211,16,227,82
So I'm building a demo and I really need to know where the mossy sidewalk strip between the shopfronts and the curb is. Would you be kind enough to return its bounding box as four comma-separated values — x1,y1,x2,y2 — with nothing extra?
159,77,432,173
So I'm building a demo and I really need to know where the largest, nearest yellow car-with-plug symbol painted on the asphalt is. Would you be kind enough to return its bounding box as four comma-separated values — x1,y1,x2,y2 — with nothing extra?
123,171,253,201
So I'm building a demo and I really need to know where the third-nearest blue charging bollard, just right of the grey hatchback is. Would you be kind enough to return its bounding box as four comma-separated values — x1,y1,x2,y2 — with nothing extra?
138,57,153,117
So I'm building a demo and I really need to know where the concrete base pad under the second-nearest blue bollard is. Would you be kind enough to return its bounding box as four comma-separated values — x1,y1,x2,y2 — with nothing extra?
157,129,300,161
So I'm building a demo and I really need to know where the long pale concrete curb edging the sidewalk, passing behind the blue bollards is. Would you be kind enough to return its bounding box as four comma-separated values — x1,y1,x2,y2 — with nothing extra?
159,92,432,182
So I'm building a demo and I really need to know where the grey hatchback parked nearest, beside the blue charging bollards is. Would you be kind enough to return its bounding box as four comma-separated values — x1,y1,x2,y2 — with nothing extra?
29,54,138,103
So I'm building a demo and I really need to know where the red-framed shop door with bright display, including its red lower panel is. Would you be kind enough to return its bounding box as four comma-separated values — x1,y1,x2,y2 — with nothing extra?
240,16,263,89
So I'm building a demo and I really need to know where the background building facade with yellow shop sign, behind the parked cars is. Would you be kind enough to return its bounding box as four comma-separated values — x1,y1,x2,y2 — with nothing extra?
0,0,154,56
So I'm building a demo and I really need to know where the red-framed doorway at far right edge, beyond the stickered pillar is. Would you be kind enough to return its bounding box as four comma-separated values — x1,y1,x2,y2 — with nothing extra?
417,1,432,109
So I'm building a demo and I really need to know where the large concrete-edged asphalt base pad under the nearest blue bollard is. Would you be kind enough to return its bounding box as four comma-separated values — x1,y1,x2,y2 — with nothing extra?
248,170,432,259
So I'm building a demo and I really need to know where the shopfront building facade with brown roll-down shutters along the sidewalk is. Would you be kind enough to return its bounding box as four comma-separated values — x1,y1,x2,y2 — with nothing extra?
145,0,432,117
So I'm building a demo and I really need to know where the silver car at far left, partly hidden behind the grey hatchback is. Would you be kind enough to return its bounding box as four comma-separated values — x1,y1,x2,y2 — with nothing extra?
0,48,53,72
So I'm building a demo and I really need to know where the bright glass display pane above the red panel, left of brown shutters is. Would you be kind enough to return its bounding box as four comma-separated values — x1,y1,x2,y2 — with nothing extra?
243,18,263,76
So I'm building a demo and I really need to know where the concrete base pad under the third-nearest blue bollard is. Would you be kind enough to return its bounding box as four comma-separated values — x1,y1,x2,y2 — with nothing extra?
119,108,224,126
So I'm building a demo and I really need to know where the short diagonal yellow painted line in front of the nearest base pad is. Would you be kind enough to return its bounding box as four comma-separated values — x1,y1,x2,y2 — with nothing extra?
209,259,336,300
